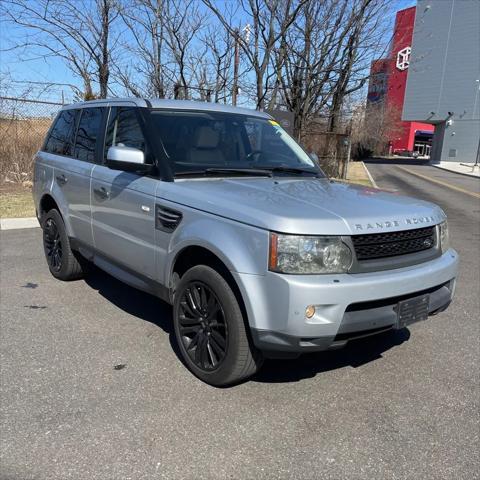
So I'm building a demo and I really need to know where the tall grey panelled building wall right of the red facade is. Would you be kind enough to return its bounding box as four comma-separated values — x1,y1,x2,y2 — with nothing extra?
402,0,480,162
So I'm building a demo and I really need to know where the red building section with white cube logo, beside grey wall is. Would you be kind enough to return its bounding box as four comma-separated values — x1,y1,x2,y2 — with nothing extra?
367,7,433,155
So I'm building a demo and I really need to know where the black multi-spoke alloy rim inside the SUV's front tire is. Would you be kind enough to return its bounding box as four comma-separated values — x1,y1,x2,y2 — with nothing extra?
178,281,228,372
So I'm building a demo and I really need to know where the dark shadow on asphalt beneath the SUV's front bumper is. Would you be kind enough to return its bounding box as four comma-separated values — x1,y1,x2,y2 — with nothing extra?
252,328,410,383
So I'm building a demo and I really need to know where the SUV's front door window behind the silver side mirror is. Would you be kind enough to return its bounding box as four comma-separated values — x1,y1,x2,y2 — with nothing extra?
104,107,153,163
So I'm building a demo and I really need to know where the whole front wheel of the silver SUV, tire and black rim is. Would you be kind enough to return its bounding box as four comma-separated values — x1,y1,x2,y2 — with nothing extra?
173,265,263,387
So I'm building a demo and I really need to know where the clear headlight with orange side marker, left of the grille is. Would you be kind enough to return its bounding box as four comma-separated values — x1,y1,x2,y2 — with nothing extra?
269,233,352,274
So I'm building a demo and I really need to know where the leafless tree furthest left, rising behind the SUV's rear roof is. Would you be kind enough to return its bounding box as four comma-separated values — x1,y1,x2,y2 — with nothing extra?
1,0,118,99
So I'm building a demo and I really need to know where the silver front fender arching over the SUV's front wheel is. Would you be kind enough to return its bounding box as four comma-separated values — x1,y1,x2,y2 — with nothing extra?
165,217,268,279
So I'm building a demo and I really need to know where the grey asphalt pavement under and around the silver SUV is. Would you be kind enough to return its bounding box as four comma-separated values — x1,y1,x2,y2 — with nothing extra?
0,161,480,480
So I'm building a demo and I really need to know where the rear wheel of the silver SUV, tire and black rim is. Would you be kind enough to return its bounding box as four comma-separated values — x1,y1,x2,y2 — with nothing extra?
42,209,83,281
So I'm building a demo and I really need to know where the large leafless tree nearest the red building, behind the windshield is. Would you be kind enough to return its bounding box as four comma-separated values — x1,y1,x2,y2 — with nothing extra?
276,0,386,138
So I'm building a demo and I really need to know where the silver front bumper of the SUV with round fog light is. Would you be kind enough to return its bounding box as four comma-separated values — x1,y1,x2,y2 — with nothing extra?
234,249,458,352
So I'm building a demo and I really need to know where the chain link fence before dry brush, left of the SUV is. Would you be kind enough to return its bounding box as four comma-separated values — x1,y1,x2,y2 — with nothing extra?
0,97,62,183
